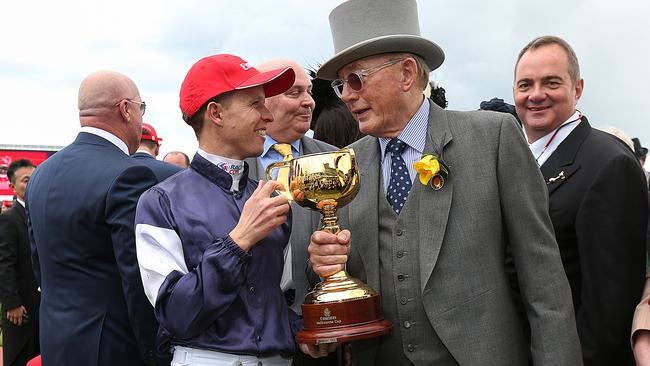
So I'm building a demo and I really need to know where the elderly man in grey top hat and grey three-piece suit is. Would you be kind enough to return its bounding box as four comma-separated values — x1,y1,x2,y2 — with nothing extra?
308,0,582,366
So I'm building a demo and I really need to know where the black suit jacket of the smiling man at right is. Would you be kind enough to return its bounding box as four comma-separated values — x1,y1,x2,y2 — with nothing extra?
508,117,648,366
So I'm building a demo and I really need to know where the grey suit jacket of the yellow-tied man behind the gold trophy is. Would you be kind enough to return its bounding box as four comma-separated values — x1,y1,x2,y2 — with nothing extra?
246,136,338,314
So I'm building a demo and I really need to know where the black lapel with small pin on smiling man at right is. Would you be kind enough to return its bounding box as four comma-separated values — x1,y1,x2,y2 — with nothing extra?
540,116,591,196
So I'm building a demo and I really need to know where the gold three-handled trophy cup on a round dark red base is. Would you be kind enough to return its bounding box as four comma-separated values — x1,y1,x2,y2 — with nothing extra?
266,149,393,344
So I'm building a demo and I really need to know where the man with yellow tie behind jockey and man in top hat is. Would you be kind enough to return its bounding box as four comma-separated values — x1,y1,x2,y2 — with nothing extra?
246,59,337,366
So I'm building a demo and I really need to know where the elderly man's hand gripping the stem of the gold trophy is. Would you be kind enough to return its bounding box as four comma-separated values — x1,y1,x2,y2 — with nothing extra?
307,230,350,277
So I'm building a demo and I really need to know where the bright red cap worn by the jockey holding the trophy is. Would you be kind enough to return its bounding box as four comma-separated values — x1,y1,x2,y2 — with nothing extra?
180,54,296,119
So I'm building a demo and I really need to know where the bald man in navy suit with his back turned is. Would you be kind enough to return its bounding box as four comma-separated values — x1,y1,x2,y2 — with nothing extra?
26,71,158,366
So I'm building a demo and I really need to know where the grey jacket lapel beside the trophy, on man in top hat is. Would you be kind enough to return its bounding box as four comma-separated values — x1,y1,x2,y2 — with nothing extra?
348,136,381,289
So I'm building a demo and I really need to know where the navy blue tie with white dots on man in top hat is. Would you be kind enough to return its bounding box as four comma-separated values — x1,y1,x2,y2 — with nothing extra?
386,139,411,215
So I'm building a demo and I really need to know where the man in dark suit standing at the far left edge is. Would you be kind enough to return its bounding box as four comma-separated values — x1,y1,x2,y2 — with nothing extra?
0,159,40,366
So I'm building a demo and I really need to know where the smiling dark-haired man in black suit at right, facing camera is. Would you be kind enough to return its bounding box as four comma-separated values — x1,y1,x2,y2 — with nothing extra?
513,36,648,366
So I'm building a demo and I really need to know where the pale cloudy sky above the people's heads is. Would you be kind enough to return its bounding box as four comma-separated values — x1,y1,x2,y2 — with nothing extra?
0,0,650,163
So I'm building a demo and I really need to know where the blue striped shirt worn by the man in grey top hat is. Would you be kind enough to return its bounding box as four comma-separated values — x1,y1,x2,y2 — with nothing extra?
379,98,429,193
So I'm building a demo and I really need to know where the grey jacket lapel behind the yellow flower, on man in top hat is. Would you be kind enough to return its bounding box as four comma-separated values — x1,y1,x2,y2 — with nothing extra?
412,103,454,291
